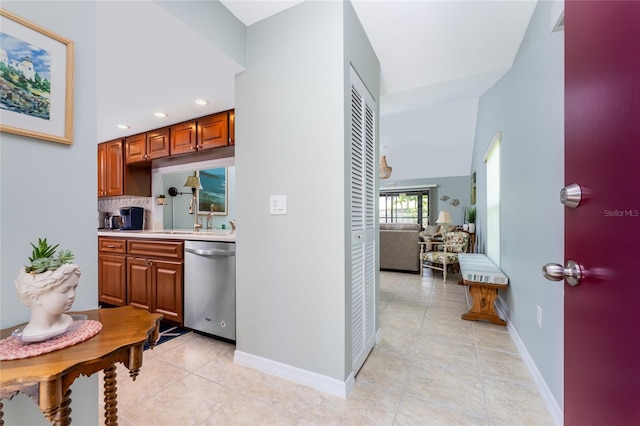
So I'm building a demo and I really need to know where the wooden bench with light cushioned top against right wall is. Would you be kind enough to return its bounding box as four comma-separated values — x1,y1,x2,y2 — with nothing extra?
458,253,509,325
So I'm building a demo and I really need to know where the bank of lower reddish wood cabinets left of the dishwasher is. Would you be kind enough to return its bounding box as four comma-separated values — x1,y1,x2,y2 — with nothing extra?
98,237,184,324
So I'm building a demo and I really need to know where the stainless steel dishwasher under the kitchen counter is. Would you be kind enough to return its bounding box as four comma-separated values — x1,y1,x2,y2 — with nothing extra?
184,241,236,341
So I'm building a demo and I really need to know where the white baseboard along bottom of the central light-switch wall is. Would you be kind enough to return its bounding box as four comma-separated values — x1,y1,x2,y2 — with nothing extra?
233,351,355,398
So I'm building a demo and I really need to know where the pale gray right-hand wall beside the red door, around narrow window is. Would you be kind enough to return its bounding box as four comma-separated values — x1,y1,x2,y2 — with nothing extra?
472,1,564,412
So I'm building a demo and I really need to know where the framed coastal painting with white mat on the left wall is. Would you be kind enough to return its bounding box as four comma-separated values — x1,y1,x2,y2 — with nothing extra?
0,9,74,145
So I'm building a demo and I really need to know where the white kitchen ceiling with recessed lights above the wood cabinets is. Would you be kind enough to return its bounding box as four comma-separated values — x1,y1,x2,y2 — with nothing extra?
96,1,243,142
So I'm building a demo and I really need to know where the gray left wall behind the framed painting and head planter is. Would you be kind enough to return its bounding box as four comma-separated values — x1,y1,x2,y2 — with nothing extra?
0,1,98,425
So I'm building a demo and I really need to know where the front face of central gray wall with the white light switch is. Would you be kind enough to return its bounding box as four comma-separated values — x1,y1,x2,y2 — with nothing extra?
236,2,379,381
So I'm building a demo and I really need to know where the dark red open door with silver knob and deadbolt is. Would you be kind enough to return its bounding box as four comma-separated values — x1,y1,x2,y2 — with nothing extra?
564,1,640,426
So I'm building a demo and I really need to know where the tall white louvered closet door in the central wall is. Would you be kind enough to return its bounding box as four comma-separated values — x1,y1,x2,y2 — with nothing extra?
351,70,376,374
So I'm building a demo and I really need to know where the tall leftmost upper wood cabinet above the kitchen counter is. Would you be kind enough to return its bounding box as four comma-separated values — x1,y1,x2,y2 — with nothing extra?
98,139,124,197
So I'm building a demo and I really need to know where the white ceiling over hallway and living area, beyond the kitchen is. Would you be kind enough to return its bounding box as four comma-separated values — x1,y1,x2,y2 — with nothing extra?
221,0,536,115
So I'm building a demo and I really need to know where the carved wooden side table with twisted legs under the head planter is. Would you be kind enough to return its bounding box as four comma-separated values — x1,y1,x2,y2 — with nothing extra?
0,306,162,425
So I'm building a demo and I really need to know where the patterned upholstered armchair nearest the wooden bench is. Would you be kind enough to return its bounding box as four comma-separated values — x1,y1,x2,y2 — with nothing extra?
420,231,469,282
